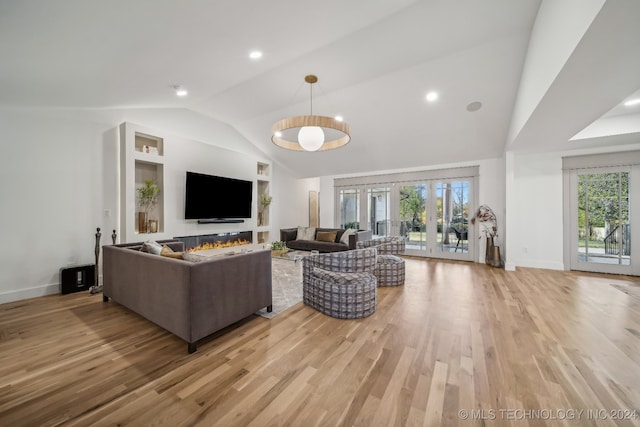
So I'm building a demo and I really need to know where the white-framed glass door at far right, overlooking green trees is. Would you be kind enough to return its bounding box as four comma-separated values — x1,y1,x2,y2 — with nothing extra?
570,166,640,275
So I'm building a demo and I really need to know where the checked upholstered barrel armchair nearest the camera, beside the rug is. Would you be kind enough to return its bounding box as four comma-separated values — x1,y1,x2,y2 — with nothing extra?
302,248,378,319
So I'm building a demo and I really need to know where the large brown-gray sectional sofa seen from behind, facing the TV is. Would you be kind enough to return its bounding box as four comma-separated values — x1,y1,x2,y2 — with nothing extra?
103,241,272,353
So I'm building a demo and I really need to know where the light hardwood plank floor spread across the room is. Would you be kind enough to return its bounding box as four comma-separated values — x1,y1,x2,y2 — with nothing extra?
0,259,640,427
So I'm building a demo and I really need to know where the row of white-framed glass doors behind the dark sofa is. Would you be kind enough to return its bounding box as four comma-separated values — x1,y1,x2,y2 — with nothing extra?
335,167,478,261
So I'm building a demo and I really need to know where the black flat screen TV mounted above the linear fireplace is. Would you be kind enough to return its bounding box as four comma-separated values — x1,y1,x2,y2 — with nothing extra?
184,172,253,220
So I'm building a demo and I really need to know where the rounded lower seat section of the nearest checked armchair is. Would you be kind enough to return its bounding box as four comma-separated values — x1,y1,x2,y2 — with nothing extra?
304,268,378,319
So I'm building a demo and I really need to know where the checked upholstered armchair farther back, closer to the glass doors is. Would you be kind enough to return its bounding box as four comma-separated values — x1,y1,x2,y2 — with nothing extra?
356,236,406,286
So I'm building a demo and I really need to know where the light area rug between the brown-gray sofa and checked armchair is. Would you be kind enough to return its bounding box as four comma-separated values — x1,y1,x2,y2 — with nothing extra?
256,258,302,319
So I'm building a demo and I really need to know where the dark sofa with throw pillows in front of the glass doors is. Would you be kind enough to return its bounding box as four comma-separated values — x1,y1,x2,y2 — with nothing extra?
280,227,373,253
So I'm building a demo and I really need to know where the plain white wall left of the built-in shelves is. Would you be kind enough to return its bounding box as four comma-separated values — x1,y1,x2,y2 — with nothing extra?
0,111,106,302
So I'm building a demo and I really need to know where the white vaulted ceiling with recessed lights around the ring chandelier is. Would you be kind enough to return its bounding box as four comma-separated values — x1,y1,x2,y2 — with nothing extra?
0,0,640,177
